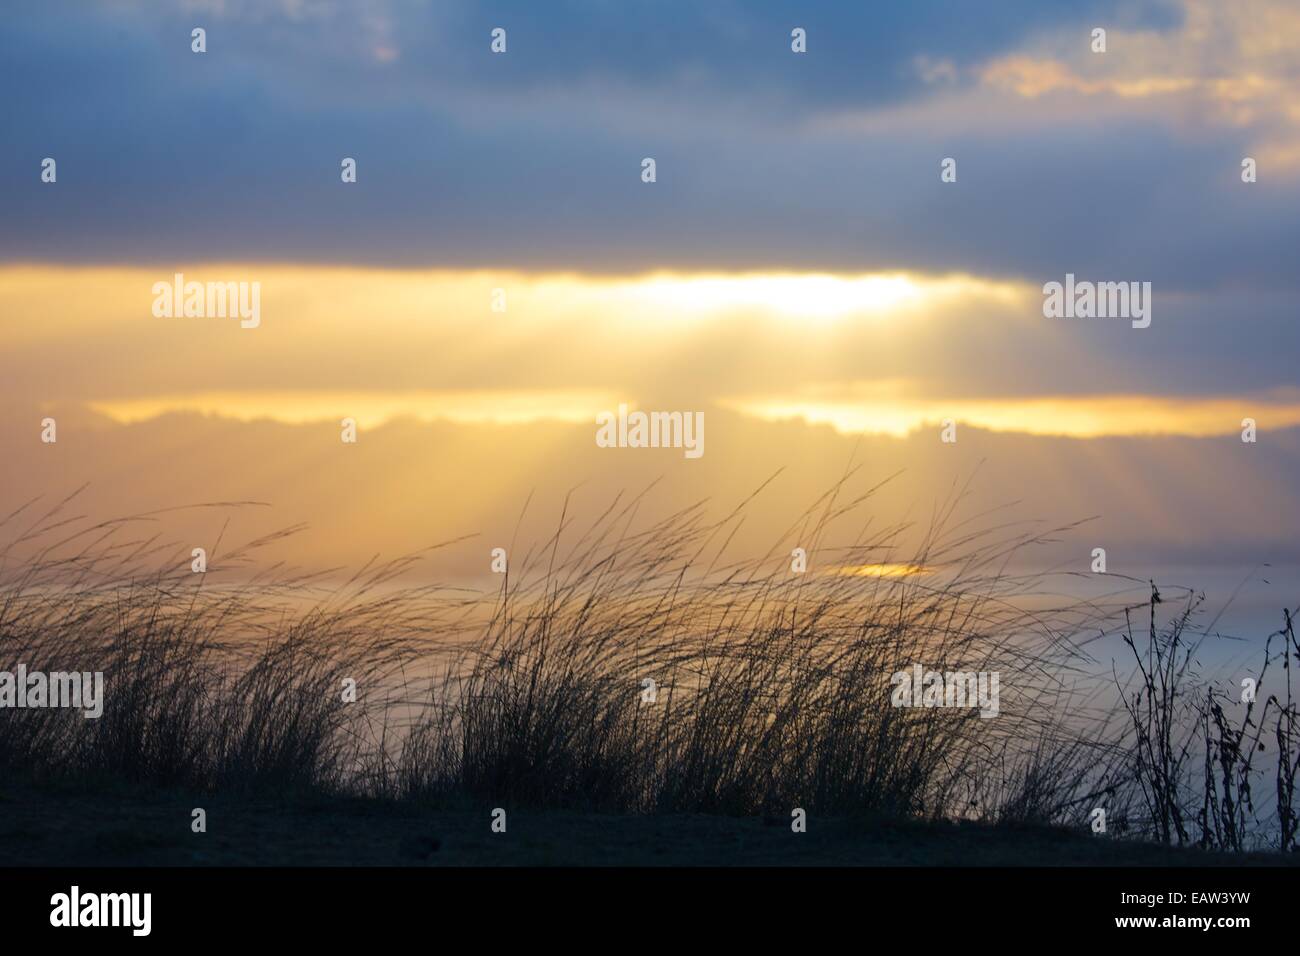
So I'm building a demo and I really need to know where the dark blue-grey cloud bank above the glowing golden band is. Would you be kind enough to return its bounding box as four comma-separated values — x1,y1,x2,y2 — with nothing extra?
12,0,1300,297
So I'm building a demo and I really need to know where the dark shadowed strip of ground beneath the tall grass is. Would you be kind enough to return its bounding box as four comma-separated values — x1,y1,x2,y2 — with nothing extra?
0,782,1300,866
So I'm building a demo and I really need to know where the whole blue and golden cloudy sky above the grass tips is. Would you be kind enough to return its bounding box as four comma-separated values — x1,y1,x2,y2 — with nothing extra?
0,0,1300,634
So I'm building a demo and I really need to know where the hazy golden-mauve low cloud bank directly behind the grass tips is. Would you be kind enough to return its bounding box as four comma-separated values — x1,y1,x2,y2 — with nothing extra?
0,405,1300,580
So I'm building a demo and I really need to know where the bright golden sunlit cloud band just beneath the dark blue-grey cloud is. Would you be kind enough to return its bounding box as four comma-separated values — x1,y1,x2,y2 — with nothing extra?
0,263,1300,421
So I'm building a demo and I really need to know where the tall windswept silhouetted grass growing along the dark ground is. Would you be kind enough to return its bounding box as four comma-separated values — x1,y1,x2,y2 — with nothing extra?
0,483,1300,849
